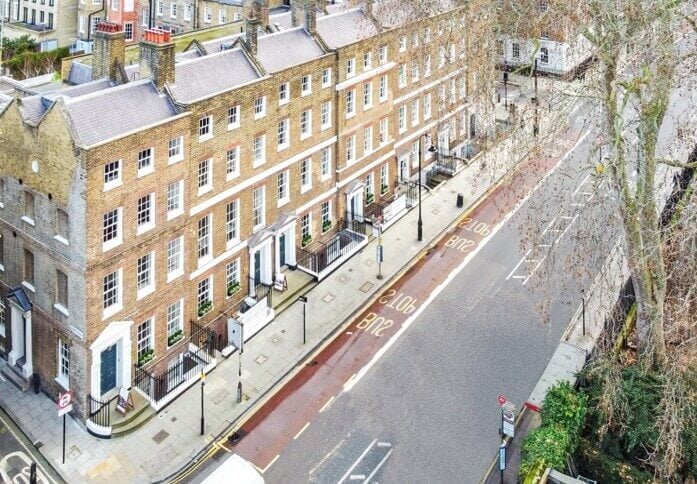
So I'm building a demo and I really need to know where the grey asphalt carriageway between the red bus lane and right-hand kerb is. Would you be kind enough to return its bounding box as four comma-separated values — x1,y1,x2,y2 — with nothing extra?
264,110,616,483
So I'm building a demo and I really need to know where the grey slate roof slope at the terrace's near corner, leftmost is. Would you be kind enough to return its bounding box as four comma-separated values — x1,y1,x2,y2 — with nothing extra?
65,79,177,145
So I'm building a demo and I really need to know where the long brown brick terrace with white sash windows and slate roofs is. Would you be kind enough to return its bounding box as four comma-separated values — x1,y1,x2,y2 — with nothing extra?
0,1,474,435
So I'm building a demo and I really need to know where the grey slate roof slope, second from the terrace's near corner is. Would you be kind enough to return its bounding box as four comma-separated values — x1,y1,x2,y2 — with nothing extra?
170,48,260,103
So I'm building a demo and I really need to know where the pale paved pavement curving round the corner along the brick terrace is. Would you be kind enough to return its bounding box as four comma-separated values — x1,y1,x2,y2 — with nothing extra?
0,70,576,482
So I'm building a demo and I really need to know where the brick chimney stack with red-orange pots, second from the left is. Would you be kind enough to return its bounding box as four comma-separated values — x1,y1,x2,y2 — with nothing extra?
140,29,175,90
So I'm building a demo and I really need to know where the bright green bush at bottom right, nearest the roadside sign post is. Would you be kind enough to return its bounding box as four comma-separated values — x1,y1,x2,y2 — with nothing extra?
519,425,571,478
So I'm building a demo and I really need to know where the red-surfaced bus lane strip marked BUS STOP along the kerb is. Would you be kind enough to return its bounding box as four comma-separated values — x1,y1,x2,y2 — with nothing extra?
234,132,579,470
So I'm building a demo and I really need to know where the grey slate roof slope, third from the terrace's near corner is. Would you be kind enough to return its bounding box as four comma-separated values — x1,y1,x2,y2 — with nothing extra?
257,27,324,73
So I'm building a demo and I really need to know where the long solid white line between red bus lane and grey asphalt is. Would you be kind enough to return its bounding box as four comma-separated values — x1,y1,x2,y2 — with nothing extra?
344,131,590,392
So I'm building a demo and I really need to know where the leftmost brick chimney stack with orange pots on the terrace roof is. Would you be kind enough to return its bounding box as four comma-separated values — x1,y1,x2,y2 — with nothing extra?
92,22,126,83
